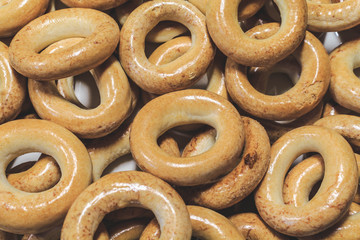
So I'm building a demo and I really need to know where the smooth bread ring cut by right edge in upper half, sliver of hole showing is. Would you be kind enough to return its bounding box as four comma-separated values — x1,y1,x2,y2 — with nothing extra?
330,39,360,113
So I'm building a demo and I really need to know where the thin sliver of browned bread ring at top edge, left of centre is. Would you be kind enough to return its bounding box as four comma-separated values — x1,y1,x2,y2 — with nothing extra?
61,0,126,10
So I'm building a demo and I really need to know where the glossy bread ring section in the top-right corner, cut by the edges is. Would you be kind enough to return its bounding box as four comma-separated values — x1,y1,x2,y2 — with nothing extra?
307,0,360,32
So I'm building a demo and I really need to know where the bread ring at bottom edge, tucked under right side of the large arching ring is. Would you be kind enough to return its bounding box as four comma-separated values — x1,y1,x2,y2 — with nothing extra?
140,206,245,240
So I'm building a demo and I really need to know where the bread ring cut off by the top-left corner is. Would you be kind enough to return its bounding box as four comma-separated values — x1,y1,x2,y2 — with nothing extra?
0,0,49,38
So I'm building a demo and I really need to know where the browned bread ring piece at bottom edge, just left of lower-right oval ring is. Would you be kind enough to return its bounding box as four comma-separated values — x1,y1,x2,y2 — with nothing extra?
229,213,289,240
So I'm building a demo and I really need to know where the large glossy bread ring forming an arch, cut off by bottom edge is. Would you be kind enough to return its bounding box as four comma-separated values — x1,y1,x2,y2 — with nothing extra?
61,171,191,240
